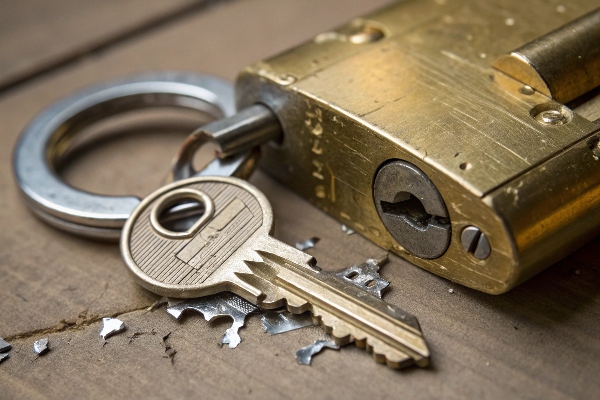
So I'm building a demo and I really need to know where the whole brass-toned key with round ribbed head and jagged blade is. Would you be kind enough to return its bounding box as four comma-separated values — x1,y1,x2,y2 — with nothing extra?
121,177,429,368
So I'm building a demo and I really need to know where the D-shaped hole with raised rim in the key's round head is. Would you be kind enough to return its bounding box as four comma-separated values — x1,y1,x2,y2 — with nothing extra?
150,189,214,239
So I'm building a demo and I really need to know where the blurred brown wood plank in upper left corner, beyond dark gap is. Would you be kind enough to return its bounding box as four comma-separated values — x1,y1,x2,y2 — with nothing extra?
0,0,206,89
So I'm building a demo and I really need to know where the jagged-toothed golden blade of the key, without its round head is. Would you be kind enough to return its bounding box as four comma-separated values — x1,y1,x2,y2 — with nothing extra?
238,239,429,368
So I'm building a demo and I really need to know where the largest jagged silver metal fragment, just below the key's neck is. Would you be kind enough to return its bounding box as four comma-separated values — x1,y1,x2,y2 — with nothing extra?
167,292,258,349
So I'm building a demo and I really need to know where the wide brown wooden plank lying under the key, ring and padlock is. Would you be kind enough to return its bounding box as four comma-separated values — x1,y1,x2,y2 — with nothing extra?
0,0,600,399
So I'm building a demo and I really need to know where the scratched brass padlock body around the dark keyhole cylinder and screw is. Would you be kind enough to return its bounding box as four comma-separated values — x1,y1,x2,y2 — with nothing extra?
237,0,600,293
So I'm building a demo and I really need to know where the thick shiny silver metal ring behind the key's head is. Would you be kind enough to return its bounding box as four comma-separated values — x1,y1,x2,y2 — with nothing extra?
13,72,254,240
